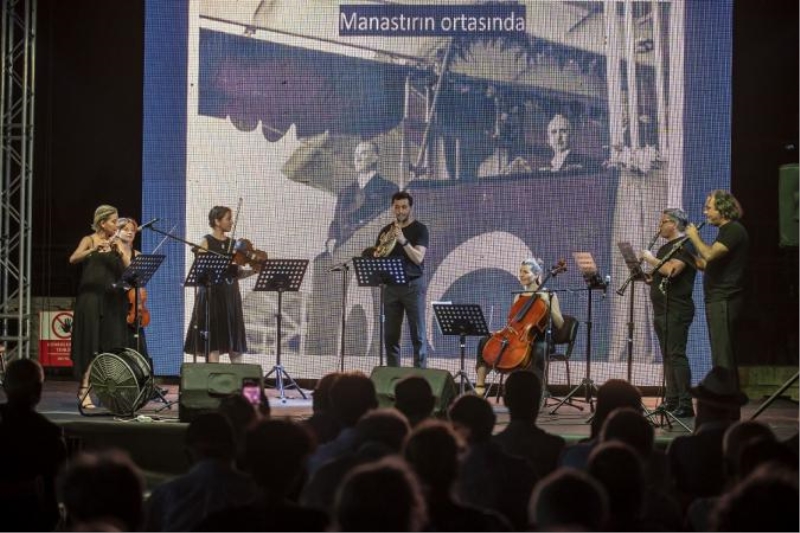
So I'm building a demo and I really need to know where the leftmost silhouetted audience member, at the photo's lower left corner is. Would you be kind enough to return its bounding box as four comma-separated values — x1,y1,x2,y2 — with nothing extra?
0,359,67,531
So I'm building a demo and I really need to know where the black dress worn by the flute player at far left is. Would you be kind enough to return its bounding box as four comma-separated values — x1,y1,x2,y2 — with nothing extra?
70,248,129,379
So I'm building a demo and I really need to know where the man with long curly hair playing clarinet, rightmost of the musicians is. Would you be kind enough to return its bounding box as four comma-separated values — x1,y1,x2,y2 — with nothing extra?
686,190,749,392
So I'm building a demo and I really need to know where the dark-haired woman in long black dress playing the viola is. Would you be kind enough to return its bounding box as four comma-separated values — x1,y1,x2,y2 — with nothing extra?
183,205,247,363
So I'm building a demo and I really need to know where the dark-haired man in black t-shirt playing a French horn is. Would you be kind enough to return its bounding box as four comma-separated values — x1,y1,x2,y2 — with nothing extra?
372,191,428,368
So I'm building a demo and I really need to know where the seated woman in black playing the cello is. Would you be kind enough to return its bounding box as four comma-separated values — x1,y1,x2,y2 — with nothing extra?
475,257,564,396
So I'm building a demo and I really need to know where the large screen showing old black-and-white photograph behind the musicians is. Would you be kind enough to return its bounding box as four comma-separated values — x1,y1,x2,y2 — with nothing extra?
144,0,731,386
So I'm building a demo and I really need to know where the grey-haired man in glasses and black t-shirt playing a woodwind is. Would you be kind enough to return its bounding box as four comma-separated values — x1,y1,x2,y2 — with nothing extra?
642,209,695,417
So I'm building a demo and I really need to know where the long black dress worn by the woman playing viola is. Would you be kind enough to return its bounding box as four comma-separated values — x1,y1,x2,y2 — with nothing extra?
183,235,247,355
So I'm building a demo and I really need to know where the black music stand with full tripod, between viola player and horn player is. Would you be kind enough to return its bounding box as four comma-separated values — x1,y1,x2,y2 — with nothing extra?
253,259,308,403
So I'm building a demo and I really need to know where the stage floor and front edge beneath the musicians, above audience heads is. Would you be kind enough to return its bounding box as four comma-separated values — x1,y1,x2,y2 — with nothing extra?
15,379,798,488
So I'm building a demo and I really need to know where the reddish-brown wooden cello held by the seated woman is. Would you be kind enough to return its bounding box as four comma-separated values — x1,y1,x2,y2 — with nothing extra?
481,259,567,372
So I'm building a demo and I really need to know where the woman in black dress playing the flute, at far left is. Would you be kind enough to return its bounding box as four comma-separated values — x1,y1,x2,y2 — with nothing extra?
69,205,131,408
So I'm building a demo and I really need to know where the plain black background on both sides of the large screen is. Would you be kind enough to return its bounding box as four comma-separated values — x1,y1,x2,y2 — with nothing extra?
33,0,799,365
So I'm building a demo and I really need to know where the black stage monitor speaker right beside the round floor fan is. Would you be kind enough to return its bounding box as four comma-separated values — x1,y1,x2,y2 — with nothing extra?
178,363,266,422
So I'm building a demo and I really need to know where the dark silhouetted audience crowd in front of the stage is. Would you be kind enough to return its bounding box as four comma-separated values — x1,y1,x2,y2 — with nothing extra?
14,360,800,531
